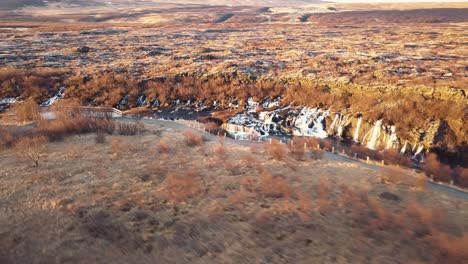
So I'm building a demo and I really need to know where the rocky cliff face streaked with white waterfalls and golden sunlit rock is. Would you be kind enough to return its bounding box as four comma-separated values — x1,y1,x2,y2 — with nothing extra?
219,98,460,158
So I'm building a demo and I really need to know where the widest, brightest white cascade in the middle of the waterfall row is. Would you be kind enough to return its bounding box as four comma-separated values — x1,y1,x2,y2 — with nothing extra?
293,107,328,138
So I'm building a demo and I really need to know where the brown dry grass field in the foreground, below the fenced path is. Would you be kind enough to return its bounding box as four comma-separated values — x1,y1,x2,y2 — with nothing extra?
0,119,468,264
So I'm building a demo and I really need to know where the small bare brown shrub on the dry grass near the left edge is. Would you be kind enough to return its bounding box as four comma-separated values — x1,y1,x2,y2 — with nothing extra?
15,136,47,167
